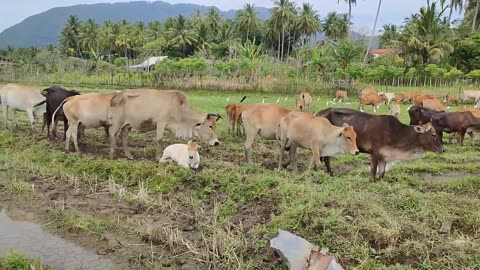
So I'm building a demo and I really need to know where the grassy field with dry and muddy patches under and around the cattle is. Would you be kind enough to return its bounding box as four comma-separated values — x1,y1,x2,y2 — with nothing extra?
0,85,480,269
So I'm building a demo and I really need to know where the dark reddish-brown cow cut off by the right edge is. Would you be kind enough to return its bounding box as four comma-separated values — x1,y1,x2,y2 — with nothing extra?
431,111,480,146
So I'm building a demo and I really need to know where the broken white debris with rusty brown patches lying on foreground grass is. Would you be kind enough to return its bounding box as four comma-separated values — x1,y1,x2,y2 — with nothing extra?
270,230,343,270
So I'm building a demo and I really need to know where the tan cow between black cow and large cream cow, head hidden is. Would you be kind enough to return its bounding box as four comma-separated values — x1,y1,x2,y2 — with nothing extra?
52,93,114,153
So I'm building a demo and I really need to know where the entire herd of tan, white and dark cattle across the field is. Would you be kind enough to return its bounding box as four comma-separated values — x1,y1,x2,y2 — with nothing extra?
0,84,480,179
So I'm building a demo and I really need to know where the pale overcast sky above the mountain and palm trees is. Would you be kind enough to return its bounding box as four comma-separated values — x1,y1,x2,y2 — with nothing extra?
0,0,464,32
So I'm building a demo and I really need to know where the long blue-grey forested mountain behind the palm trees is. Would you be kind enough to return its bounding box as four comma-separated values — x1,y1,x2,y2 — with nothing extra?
0,1,270,48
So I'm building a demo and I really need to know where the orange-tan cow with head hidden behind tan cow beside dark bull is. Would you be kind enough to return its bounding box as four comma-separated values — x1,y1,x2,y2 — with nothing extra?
241,103,292,162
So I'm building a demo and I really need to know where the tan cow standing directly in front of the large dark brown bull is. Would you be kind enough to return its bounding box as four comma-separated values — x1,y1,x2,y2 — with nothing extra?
277,112,360,171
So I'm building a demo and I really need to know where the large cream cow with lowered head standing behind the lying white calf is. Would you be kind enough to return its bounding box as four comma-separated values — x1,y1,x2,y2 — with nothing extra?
108,89,221,159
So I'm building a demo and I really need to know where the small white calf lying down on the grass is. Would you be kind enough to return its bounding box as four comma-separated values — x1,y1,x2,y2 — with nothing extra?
160,141,201,169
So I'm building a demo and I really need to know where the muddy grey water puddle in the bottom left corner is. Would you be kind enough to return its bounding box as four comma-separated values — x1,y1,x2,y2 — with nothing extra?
0,208,113,270
